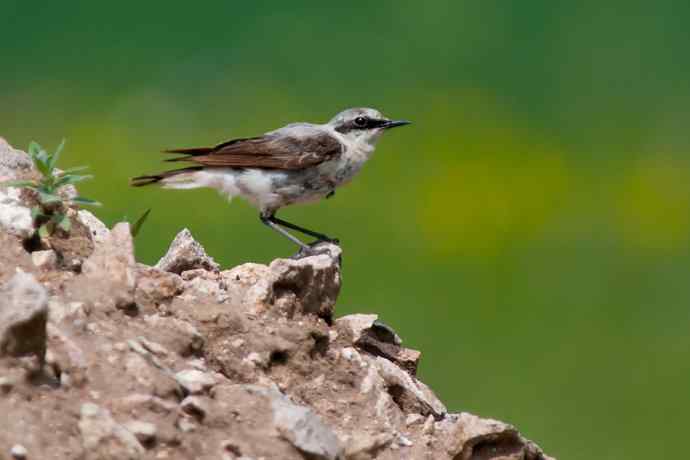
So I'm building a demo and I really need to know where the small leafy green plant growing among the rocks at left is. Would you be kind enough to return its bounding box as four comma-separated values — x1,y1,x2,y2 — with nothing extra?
0,140,100,238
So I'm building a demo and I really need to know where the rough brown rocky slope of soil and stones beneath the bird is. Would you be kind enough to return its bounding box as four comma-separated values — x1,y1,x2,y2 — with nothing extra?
0,143,549,460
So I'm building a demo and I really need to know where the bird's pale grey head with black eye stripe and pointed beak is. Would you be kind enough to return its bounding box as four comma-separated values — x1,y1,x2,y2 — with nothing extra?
328,108,410,145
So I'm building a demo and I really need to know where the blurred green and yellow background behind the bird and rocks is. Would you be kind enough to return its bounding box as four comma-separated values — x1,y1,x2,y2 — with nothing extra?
0,0,690,459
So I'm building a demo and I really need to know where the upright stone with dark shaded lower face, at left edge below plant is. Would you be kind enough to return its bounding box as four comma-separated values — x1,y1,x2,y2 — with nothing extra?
0,271,48,361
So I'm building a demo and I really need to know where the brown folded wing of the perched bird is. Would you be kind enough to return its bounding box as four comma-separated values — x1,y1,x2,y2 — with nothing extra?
168,129,343,170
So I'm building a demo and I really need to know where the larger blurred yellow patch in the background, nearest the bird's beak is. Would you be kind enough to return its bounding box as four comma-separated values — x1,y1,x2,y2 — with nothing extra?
417,151,570,257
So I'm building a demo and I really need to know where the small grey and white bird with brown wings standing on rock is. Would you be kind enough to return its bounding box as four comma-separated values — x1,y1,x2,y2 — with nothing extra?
131,108,410,256
